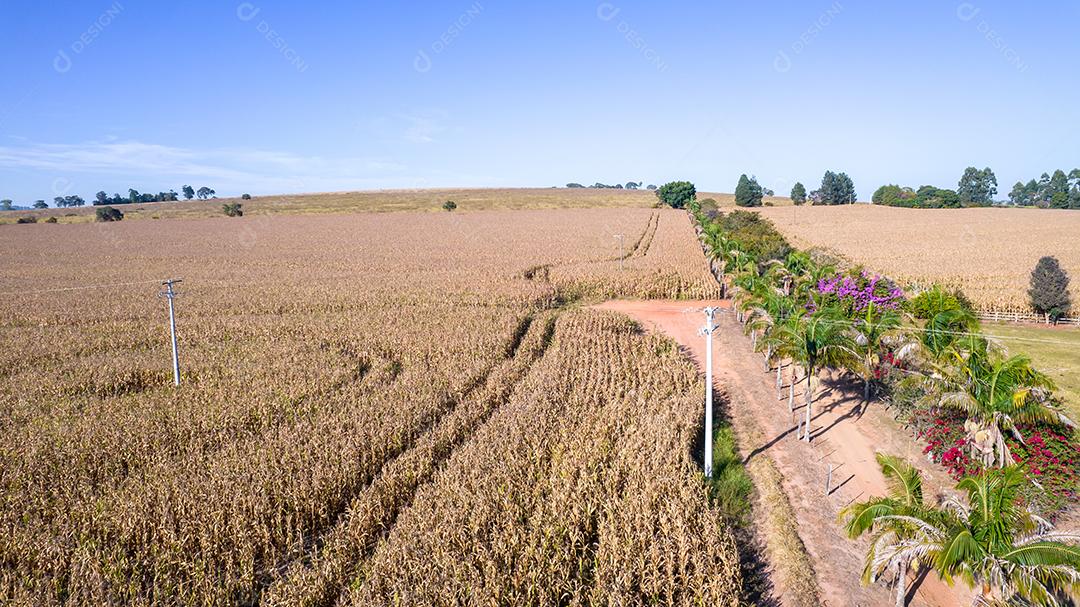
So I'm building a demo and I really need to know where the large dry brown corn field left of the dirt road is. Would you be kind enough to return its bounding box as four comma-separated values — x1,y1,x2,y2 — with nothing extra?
0,208,741,606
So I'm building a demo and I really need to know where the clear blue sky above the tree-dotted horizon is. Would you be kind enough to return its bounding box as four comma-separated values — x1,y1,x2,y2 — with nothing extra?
0,0,1080,204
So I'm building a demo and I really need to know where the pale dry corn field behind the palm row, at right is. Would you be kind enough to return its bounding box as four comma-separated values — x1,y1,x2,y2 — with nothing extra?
761,204,1080,312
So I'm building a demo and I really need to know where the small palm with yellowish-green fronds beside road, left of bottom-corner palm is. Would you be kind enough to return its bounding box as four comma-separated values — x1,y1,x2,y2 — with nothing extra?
840,453,934,607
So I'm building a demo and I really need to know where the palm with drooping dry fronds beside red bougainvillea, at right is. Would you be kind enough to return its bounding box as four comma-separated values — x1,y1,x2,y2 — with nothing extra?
928,338,1069,468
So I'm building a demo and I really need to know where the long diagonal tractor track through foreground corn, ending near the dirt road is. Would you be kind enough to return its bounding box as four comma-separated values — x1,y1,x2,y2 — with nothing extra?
252,311,557,605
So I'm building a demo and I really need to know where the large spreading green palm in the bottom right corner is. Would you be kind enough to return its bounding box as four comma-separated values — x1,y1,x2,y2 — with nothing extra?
854,466,1080,606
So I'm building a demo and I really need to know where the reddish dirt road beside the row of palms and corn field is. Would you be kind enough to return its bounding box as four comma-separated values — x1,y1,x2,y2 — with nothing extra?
598,300,971,607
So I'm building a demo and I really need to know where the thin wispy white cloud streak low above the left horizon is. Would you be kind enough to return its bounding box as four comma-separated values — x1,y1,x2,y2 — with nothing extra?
0,138,413,193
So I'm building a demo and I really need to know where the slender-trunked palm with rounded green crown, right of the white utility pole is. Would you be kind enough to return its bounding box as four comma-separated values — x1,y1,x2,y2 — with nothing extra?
777,308,854,443
